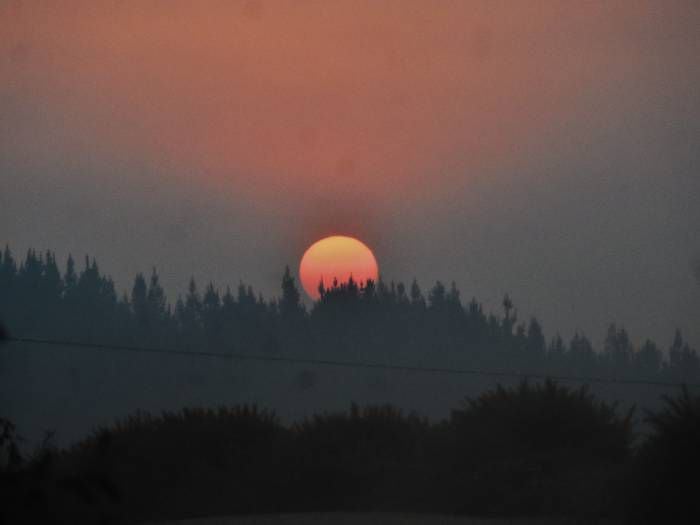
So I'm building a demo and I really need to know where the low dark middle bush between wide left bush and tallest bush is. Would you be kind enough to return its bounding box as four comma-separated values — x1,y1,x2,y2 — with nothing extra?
292,404,430,511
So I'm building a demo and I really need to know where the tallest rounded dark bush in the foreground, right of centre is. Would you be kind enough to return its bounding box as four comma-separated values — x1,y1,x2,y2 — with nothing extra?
450,380,632,515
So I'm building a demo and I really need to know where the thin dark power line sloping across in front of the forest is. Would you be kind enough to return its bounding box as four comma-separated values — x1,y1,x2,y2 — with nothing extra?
6,337,700,388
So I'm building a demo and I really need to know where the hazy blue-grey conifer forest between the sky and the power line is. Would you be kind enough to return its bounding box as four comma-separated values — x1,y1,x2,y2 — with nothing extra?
0,248,700,383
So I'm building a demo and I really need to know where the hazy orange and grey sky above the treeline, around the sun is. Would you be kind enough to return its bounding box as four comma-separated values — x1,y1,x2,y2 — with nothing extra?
0,0,700,346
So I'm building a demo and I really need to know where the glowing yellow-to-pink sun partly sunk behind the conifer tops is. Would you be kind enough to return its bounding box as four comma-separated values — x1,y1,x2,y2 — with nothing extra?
299,235,379,300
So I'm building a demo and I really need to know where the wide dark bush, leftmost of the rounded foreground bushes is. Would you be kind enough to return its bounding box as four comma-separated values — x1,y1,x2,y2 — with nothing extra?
71,406,288,520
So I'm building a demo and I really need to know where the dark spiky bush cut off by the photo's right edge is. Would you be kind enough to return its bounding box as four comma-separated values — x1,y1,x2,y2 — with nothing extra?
629,388,700,524
